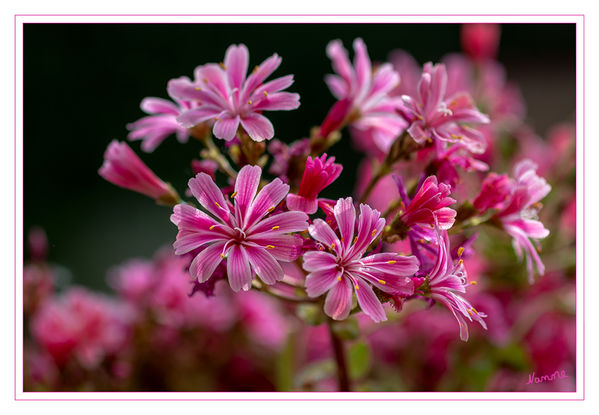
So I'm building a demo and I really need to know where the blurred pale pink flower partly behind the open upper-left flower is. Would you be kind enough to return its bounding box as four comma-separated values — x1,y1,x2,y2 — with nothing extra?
127,97,191,152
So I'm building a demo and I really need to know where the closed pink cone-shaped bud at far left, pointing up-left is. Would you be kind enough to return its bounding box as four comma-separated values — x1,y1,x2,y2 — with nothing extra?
99,140,178,202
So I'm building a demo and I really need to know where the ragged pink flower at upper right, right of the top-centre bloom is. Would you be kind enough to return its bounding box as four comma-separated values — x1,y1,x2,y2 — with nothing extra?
402,62,489,153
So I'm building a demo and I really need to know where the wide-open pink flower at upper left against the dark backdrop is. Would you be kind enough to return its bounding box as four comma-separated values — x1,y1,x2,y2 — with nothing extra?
169,44,299,141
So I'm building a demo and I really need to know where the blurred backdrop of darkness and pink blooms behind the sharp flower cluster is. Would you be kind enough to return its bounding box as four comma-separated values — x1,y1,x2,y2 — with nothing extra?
24,24,576,391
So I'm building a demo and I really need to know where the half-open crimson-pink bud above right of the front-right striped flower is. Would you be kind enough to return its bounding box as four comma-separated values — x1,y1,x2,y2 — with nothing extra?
396,176,456,230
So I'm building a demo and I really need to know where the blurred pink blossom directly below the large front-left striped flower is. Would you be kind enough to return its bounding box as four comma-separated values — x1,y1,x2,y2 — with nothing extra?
235,291,289,350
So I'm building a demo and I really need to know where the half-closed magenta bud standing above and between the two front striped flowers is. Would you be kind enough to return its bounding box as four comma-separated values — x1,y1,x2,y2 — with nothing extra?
287,153,343,215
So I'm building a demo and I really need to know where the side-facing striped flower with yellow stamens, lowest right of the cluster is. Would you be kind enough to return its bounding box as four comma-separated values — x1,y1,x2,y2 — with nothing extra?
416,227,487,341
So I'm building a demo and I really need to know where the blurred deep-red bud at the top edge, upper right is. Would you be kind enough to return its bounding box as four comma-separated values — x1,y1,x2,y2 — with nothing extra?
461,23,501,60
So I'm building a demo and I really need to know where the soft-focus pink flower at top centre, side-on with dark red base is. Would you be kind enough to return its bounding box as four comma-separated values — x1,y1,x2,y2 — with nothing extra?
321,39,406,152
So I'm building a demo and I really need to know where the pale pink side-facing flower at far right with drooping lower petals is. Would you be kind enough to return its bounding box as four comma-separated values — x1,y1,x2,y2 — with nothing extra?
495,160,551,283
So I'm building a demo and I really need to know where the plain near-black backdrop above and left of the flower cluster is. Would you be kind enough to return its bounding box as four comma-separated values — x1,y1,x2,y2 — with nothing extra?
24,24,575,288
